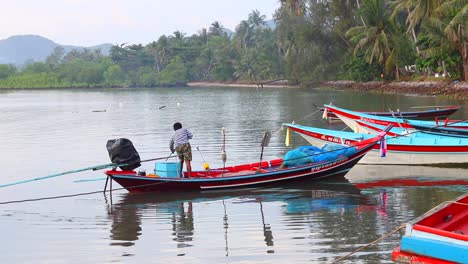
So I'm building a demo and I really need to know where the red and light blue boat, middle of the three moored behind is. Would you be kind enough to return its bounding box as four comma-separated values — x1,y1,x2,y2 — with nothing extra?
324,105,468,132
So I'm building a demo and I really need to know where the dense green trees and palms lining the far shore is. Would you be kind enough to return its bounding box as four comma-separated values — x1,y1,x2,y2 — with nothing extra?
0,0,468,88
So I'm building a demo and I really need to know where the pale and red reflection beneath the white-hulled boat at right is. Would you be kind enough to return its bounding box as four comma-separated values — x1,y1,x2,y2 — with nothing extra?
346,164,468,190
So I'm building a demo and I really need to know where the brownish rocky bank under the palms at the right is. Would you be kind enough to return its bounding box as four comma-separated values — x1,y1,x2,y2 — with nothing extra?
320,81,468,99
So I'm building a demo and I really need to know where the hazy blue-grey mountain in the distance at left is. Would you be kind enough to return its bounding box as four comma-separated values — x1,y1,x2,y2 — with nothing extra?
0,35,112,65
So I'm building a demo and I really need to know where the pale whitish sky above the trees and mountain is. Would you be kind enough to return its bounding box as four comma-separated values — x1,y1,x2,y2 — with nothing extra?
0,0,280,47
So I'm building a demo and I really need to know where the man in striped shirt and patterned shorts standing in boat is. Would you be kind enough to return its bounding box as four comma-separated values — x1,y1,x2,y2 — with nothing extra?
169,122,192,177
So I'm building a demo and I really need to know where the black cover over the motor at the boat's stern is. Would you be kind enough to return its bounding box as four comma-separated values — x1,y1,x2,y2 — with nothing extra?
106,138,141,170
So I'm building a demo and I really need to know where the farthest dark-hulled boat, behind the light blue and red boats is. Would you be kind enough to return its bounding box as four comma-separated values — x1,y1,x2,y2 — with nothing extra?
320,106,460,119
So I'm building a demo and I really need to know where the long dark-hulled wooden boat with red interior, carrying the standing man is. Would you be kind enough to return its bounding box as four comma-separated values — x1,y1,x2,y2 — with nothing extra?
105,136,381,193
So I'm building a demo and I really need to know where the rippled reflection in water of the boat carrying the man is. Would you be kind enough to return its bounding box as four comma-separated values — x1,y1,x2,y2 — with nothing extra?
106,178,380,251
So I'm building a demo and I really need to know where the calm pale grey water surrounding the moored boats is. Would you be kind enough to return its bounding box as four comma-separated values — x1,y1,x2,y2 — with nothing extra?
0,88,468,263
